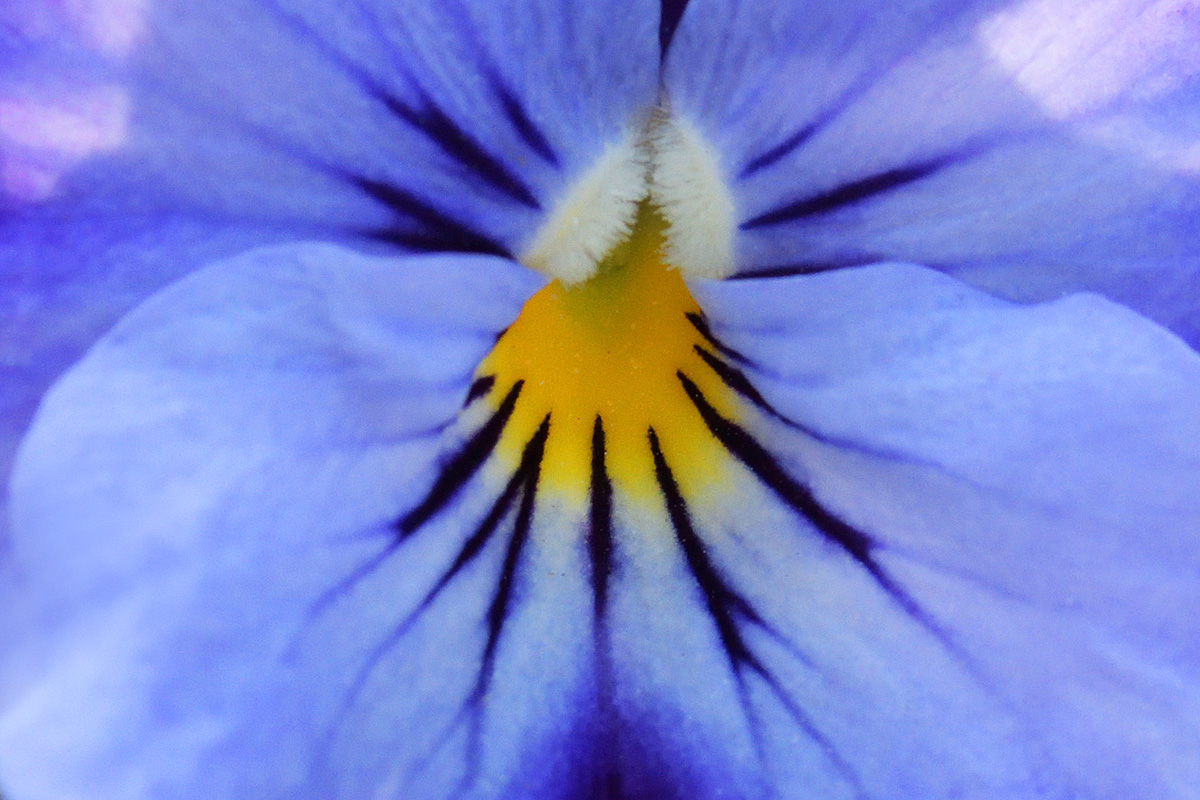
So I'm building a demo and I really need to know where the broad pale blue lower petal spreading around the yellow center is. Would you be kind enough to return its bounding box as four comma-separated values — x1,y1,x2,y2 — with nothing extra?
9,245,1200,800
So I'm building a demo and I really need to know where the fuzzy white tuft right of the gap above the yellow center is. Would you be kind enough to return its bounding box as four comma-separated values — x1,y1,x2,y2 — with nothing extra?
650,118,737,279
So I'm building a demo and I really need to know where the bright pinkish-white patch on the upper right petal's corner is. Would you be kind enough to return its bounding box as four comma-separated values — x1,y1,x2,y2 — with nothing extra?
978,0,1200,119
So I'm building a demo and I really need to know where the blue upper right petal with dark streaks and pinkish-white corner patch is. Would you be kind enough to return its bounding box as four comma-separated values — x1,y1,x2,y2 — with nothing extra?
665,0,1200,347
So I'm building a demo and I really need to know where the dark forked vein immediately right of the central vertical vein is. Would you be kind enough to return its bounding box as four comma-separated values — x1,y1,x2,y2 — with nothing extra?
648,428,865,798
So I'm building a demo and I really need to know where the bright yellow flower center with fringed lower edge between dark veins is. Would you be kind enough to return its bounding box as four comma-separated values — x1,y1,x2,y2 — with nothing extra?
478,204,737,503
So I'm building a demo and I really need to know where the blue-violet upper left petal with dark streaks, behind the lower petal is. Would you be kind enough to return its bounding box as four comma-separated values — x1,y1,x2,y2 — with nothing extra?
0,0,659,537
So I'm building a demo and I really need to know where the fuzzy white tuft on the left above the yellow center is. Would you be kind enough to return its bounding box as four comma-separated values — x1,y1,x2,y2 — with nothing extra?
520,136,647,285
